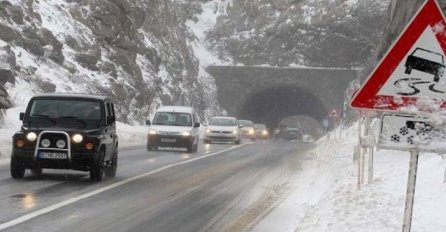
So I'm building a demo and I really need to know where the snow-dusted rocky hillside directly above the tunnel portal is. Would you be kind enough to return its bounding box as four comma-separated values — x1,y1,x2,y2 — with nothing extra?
208,0,388,67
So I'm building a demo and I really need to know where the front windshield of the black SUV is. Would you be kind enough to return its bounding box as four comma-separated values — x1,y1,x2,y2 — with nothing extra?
28,99,101,128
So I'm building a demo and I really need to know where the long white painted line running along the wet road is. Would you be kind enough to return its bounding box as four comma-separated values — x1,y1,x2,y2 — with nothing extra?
0,143,251,230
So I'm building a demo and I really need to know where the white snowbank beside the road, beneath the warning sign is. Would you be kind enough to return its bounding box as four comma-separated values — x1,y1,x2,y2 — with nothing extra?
253,122,446,232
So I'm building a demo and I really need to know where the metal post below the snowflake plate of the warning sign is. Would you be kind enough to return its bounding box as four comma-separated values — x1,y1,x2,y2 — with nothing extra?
403,150,420,232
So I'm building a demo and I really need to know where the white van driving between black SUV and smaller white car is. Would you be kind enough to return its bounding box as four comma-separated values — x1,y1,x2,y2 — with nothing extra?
146,106,200,152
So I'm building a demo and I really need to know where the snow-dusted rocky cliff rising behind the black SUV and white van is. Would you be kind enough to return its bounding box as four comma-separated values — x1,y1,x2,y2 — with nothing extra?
0,0,215,122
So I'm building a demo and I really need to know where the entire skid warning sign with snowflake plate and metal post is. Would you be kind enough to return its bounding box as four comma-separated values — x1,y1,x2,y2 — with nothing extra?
350,0,446,232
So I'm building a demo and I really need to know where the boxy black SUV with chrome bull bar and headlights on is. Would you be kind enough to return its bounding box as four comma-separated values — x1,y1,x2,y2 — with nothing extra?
11,94,118,181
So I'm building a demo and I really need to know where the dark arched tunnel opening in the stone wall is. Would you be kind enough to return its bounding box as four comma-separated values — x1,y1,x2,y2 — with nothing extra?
237,86,327,134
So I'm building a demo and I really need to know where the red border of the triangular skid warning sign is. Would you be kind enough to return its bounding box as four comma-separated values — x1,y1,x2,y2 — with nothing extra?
350,0,446,111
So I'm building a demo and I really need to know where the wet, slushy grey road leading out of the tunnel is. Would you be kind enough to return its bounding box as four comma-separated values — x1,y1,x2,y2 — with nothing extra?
0,141,313,232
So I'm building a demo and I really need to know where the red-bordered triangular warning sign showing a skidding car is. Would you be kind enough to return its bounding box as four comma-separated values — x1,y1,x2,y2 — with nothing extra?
351,0,446,110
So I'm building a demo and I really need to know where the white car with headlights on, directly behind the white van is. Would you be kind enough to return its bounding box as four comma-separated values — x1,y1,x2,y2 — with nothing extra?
203,117,241,144
